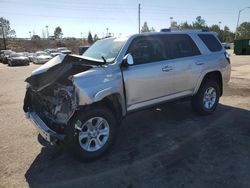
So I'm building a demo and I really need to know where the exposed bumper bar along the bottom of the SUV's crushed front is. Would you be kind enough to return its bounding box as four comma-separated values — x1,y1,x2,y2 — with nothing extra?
26,112,65,144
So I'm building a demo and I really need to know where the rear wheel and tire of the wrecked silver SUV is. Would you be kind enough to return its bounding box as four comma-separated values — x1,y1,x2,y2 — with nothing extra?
191,80,220,115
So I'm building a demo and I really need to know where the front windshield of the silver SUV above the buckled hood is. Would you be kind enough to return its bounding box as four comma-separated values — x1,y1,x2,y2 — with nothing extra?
82,38,127,63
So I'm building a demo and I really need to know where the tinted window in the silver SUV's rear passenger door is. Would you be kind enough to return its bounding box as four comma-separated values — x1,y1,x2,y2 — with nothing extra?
167,34,201,58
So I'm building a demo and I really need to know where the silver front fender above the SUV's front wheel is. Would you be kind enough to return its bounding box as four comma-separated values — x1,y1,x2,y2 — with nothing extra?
73,69,126,114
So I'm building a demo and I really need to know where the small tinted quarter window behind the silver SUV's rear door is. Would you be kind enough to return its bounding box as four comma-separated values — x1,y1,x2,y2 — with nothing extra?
198,34,222,52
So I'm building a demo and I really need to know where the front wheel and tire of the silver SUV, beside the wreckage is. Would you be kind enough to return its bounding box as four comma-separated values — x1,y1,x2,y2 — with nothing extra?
65,106,117,161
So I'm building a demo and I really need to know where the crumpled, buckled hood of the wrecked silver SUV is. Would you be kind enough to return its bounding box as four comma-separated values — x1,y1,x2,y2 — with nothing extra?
25,55,99,91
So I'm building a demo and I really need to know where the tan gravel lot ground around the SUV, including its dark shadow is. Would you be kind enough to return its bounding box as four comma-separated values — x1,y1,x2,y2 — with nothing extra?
0,51,250,188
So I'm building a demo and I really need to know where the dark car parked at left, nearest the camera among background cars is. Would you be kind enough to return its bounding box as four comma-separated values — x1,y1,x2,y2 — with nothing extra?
8,53,30,66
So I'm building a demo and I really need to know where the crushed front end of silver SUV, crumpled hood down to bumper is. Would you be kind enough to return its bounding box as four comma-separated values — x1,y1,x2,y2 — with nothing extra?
23,55,96,144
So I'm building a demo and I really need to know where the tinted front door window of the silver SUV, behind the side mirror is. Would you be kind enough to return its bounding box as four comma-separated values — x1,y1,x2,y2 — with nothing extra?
127,36,167,65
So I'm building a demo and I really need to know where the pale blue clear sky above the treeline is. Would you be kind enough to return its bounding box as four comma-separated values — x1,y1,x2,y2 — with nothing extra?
0,0,250,38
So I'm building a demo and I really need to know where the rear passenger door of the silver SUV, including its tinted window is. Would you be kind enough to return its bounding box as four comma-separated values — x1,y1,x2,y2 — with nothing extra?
164,34,204,96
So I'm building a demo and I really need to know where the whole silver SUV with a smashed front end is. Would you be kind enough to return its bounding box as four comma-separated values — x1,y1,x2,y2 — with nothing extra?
23,31,231,160
